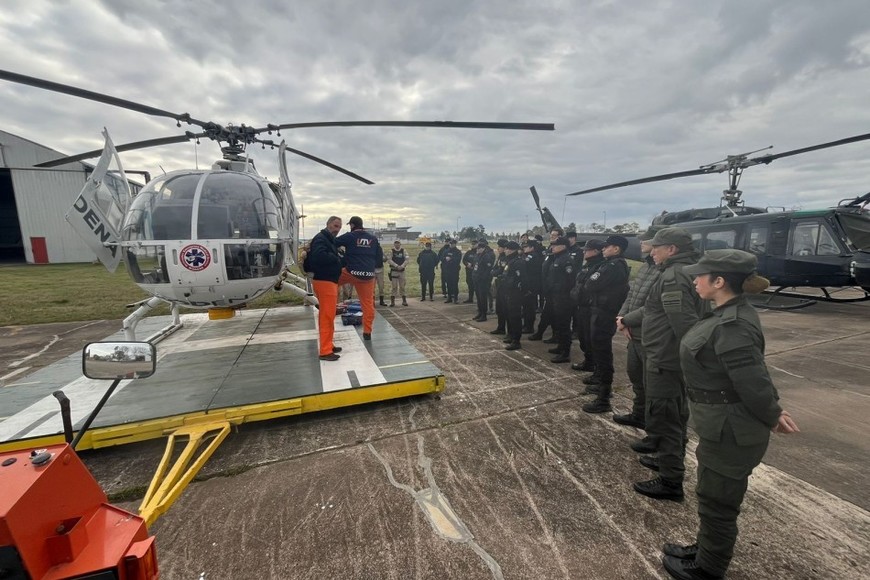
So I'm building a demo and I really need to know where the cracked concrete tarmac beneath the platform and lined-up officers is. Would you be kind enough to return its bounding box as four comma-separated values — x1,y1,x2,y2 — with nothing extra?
0,299,870,579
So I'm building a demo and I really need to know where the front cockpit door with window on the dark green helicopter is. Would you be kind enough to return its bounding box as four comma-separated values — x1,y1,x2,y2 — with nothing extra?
785,218,849,287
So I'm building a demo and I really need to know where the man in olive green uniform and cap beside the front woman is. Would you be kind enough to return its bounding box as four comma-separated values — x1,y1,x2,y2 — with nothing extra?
622,228,707,501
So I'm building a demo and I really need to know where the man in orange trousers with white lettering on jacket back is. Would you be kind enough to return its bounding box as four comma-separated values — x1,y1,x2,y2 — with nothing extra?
335,216,382,340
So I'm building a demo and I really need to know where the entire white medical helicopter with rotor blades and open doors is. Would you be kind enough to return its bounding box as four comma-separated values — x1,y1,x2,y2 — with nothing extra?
0,70,555,341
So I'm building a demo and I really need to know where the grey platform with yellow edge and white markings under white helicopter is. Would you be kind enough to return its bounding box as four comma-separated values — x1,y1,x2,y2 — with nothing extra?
0,306,444,450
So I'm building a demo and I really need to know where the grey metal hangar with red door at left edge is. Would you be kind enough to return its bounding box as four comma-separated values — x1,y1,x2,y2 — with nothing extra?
0,131,139,264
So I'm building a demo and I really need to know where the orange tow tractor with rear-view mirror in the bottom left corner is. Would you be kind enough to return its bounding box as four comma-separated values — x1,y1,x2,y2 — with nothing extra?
0,342,159,580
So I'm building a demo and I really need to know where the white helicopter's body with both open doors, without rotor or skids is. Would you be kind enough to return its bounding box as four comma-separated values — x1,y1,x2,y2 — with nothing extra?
67,138,298,308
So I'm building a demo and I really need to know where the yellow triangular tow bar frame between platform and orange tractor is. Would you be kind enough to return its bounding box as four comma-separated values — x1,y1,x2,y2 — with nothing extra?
139,421,230,526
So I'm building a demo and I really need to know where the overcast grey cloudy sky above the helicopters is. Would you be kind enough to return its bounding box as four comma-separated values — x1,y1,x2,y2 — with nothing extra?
0,0,870,235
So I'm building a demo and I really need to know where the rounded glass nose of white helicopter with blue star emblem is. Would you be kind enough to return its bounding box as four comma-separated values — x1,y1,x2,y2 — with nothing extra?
121,168,289,308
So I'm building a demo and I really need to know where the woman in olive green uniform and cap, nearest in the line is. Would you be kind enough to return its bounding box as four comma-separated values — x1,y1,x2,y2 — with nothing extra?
660,250,799,580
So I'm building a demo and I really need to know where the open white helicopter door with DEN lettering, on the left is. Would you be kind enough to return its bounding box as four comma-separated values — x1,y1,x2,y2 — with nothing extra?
65,129,132,272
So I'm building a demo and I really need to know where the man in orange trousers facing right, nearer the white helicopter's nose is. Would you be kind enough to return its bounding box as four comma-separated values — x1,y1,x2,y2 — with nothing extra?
304,216,341,361
